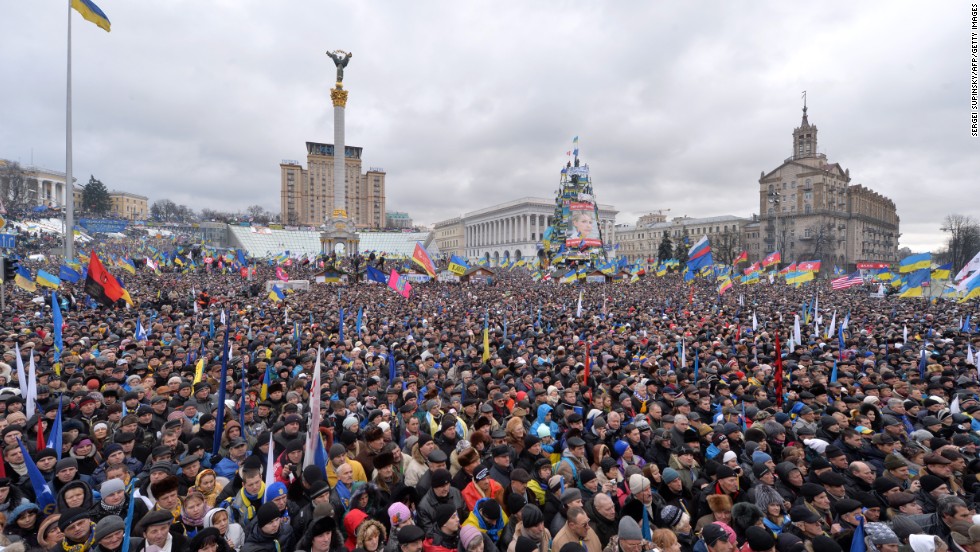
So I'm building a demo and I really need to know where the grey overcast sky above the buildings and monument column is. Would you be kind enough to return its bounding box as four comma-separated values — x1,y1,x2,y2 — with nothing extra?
0,0,980,250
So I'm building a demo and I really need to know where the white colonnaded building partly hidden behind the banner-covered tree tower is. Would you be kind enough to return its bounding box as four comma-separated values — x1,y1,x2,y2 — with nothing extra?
435,197,618,264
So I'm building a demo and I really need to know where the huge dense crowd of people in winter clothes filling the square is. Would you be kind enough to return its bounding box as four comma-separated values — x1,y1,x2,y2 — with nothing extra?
0,234,980,552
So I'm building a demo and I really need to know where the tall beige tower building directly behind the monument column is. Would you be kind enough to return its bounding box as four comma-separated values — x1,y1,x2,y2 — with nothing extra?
279,142,386,229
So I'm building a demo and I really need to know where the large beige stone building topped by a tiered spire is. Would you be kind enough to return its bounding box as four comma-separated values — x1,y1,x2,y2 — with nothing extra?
746,106,900,271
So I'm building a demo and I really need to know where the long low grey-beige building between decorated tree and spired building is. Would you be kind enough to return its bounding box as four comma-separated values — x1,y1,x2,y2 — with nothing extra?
616,213,750,264
